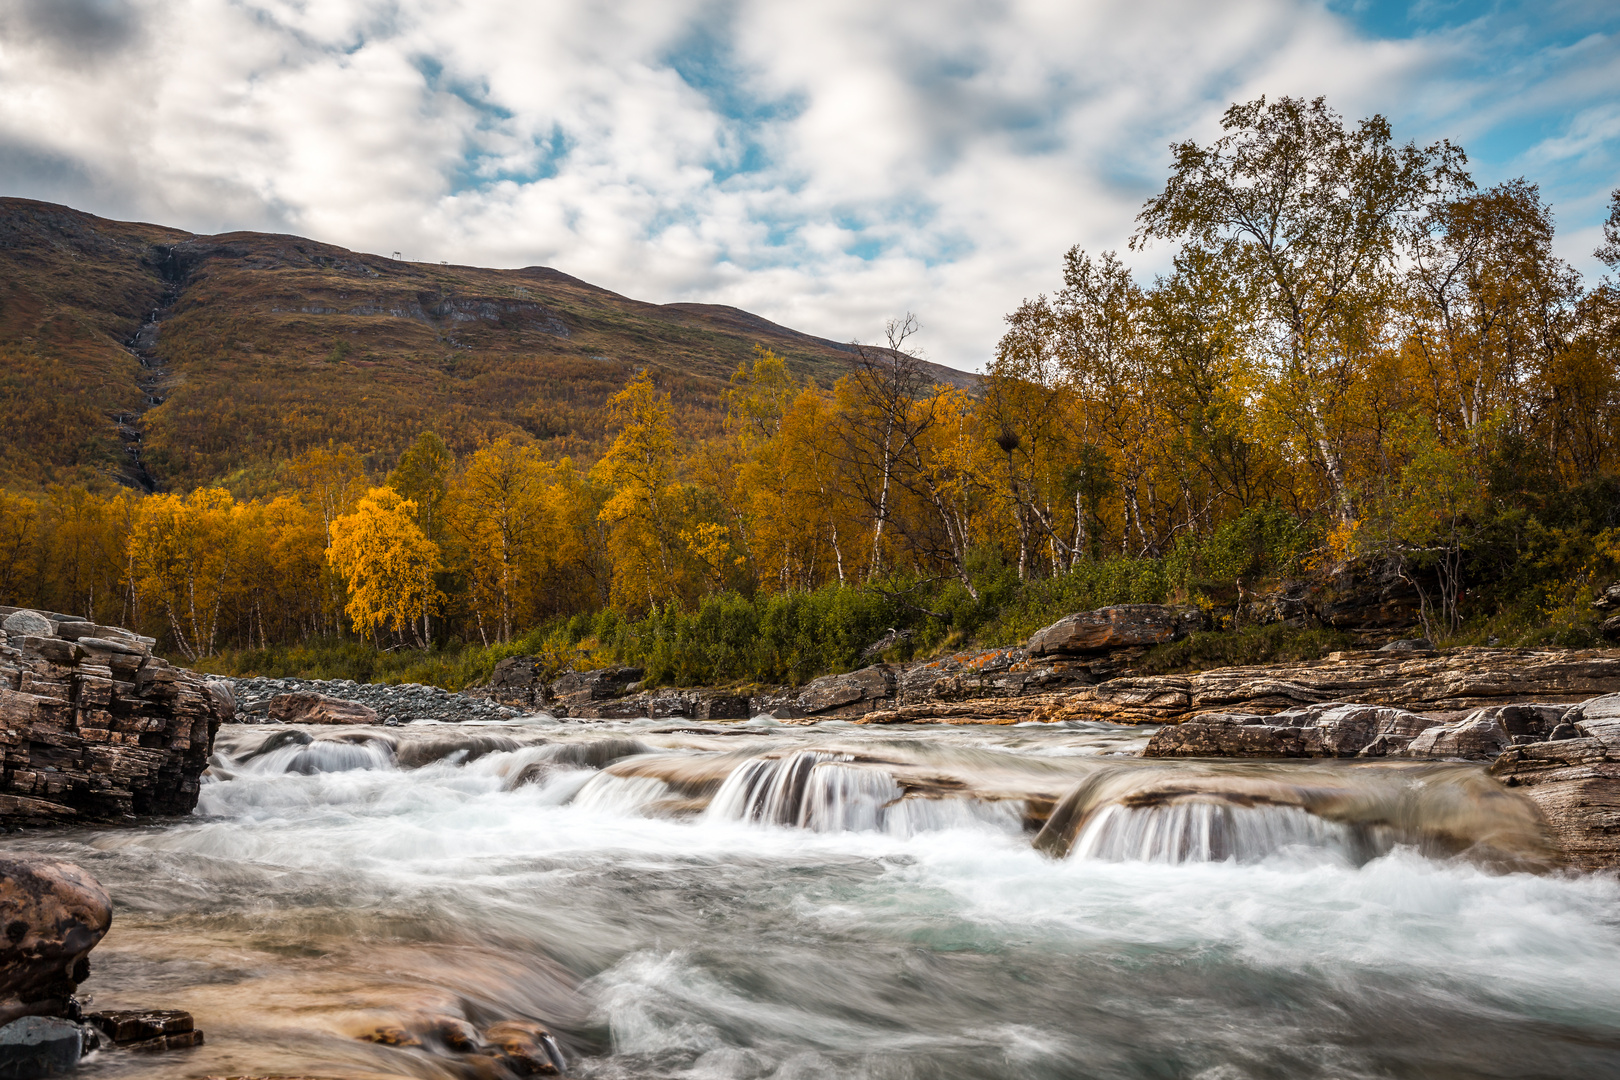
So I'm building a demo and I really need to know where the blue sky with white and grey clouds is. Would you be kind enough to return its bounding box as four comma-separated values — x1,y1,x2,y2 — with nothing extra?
0,0,1620,371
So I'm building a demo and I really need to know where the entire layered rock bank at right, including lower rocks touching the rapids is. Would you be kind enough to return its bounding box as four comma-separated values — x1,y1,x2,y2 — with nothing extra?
447,606,1620,870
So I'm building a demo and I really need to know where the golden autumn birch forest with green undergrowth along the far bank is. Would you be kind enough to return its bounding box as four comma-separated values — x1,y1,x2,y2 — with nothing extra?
0,97,1620,687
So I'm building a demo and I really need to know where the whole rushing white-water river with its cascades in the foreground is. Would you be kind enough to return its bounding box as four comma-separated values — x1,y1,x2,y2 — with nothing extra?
9,719,1620,1080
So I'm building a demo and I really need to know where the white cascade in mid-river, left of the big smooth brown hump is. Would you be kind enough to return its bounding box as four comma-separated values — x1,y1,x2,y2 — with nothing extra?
705,750,1024,837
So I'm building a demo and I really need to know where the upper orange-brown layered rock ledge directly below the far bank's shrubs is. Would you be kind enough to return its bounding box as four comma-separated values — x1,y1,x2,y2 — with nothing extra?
456,615,1620,724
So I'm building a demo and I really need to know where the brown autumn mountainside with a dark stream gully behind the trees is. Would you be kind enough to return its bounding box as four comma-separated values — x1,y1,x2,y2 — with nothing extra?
0,199,977,494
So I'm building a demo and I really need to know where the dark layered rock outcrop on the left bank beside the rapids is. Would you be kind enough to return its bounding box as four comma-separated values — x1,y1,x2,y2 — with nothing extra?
0,607,235,826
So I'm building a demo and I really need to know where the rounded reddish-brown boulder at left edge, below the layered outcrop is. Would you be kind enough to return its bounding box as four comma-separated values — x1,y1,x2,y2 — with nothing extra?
0,853,112,1022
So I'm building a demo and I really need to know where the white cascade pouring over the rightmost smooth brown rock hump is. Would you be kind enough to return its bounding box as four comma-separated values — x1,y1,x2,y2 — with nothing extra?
1072,801,1392,865
